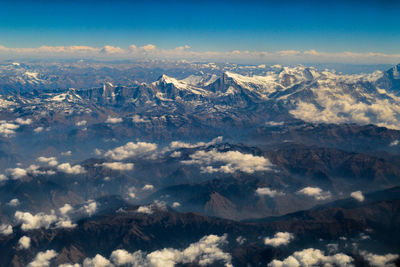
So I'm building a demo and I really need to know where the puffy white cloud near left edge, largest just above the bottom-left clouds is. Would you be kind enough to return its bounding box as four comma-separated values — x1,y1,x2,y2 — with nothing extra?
14,211,57,231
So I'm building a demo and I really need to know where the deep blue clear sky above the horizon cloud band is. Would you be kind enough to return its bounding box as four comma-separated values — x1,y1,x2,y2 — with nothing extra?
0,0,400,54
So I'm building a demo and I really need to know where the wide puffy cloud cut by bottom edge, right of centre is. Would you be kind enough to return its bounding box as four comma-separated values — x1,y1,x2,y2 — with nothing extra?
268,248,353,267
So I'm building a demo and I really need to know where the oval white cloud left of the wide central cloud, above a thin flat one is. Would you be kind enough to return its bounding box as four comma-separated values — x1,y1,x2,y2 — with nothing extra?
104,142,157,160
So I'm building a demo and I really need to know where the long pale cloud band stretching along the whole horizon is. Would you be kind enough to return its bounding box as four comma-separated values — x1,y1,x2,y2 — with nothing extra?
0,44,400,64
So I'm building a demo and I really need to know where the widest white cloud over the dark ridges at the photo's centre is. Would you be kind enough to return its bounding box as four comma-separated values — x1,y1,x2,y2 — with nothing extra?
181,149,273,173
